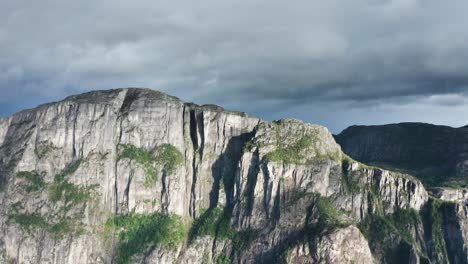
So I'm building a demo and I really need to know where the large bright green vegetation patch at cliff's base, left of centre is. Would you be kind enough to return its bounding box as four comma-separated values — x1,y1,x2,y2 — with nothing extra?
105,213,187,263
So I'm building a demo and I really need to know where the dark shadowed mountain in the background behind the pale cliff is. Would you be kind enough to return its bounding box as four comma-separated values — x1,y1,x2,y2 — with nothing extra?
335,123,468,187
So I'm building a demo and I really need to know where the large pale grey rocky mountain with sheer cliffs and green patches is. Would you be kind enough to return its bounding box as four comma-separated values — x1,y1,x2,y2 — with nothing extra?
0,88,468,264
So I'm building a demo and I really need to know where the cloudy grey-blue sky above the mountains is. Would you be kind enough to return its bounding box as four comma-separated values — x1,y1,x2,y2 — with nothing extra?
0,0,468,133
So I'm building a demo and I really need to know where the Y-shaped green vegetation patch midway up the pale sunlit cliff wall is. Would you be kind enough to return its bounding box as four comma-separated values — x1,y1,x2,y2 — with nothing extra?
117,144,184,185
